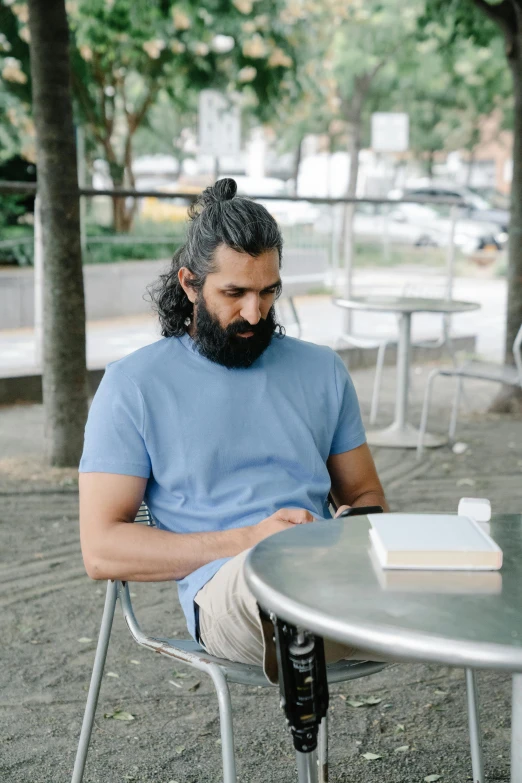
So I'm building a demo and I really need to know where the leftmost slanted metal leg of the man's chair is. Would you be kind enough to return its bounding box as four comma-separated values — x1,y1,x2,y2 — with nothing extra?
71,581,118,783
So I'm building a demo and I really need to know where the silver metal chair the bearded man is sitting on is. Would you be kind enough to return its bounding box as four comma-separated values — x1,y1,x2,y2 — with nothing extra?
71,503,386,783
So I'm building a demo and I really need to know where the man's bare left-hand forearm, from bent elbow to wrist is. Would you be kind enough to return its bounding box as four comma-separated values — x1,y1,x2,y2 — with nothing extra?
83,522,256,582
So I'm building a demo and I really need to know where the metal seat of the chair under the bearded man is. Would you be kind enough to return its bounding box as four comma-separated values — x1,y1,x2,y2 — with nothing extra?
149,639,386,687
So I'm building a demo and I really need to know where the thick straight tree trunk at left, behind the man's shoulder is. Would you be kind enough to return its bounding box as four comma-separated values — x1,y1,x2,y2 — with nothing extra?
29,0,87,467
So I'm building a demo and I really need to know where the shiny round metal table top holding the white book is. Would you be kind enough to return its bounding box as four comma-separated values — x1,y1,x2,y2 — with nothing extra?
245,514,522,672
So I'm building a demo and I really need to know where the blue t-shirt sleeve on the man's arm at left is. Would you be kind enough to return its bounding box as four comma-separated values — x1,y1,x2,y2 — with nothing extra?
79,365,151,478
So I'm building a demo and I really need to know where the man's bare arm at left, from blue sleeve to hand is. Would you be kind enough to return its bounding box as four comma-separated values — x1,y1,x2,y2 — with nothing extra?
80,473,312,582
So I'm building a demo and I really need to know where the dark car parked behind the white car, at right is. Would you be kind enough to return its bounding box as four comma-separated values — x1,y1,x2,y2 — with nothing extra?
388,182,509,234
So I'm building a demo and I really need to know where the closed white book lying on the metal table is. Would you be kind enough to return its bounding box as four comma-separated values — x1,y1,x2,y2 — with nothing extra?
368,514,502,571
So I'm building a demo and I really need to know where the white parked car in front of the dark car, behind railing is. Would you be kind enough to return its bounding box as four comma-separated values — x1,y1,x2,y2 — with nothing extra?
354,203,505,253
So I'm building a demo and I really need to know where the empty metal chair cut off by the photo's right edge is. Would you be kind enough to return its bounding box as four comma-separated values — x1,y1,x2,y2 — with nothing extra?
417,325,522,459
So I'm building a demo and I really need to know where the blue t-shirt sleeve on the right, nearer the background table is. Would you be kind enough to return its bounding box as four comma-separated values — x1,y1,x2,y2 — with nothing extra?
330,354,366,454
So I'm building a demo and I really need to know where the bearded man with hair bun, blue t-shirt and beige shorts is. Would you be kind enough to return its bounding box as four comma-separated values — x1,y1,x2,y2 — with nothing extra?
80,179,386,679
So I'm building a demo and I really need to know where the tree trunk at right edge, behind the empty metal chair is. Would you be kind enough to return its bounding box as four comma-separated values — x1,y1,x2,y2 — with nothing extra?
491,51,522,412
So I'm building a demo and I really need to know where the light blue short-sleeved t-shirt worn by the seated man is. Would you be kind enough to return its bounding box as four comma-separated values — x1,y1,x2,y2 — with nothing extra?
80,334,366,637
